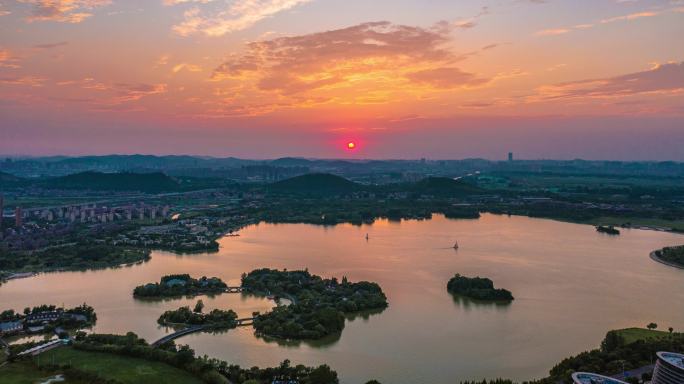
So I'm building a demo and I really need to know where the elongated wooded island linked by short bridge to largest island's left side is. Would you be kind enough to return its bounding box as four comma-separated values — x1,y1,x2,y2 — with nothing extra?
133,274,228,298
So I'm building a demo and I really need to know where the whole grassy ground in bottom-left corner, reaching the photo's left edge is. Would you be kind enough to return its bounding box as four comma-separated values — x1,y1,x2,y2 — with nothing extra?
0,347,207,384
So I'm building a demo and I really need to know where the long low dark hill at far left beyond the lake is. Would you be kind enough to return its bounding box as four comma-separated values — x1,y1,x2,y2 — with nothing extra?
41,172,180,192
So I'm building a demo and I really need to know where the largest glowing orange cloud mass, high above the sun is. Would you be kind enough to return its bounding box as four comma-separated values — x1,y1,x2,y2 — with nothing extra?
213,21,486,98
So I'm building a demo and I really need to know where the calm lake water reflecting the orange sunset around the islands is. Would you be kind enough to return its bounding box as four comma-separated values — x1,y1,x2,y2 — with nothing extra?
0,215,684,384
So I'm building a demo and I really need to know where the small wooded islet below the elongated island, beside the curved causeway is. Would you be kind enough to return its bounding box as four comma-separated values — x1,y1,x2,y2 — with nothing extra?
157,300,237,329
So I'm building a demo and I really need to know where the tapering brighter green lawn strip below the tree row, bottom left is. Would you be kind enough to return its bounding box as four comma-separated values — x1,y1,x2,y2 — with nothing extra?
34,347,202,384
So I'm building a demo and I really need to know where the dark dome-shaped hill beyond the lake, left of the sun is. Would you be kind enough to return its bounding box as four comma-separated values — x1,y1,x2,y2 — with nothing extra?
268,173,361,195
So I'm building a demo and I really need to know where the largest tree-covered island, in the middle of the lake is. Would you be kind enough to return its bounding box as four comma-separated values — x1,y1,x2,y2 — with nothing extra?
242,269,387,340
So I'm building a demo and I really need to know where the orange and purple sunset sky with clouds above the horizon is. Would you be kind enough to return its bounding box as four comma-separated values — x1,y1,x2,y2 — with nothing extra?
0,0,684,161
